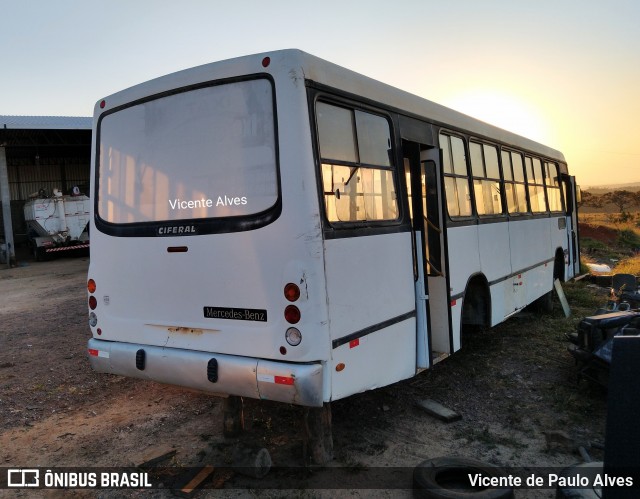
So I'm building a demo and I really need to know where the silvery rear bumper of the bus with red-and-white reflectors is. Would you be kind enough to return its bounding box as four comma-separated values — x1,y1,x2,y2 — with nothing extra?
87,338,323,407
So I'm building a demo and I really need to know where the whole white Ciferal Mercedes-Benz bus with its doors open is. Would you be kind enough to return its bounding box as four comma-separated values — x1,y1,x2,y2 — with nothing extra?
88,50,579,424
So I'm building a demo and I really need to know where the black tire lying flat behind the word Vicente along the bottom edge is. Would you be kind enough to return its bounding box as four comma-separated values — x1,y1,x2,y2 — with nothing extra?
413,457,514,499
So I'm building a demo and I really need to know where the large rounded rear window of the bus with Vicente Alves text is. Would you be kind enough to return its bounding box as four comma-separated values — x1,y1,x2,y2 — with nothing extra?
97,79,278,224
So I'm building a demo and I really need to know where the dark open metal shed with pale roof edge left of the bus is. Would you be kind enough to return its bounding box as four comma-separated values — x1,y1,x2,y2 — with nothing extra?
0,115,92,261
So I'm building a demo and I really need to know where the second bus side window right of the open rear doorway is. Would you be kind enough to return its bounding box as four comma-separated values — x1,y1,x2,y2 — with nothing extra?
469,142,502,216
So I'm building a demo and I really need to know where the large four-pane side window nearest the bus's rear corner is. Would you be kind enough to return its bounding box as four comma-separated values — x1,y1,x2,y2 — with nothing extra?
316,102,398,222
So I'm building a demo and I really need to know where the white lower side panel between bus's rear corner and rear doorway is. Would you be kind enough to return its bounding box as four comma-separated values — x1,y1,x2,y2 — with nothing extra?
325,232,416,400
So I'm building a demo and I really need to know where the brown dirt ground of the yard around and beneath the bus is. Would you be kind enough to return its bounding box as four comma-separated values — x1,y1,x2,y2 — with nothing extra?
0,257,606,498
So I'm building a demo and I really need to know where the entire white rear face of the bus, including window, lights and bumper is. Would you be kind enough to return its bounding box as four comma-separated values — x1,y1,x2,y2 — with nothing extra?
88,52,330,406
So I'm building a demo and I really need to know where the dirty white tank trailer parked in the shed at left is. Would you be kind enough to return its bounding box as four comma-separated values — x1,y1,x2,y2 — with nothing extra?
24,188,90,261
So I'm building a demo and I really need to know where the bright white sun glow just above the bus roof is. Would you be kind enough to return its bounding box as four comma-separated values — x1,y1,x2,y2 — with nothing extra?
444,89,550,144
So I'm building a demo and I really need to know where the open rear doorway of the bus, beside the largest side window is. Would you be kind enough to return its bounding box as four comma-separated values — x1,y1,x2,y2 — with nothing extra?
403,141,453,369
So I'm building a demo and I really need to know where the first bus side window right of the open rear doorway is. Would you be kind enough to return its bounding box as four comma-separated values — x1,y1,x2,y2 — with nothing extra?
440,133,472,218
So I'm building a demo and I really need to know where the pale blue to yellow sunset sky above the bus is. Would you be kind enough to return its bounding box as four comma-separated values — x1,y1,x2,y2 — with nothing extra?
0,0,640,186
